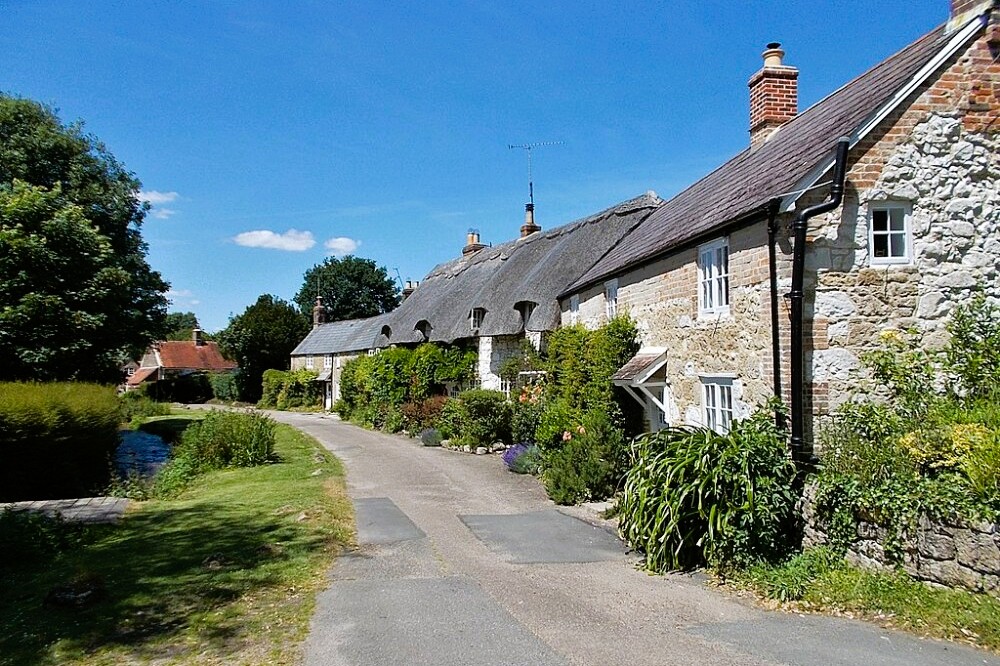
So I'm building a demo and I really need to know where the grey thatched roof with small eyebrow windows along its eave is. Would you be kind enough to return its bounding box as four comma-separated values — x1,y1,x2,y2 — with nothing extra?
378,192,663,346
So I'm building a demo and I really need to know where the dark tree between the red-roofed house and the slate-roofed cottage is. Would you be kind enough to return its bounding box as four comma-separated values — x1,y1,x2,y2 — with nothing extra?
216,294,310,402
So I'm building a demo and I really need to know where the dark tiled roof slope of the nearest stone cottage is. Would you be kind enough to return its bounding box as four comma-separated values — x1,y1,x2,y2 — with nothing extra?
567,27,947,293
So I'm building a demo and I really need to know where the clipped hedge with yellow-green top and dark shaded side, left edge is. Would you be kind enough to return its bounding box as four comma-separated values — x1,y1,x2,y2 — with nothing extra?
0,382,122,502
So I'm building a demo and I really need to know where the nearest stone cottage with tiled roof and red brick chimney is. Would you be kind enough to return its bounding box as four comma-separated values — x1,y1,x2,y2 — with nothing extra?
560,0,1000,456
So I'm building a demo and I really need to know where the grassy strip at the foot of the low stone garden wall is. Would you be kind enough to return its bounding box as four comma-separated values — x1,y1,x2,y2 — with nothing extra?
729,548,1000,652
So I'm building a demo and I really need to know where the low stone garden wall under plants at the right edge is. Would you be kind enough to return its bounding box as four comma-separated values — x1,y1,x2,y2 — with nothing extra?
802,486,1000,594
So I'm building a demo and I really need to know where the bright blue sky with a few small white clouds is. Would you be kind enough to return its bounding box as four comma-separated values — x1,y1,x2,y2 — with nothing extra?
0,0,948,330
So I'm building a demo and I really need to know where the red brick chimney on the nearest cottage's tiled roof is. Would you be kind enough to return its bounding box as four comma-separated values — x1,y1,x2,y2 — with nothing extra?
748,42,799,148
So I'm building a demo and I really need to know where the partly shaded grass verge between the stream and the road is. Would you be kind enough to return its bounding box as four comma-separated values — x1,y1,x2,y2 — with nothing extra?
0,426,353,666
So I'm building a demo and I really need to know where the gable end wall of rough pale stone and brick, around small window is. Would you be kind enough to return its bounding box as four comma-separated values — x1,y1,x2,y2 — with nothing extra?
803,28,1000,414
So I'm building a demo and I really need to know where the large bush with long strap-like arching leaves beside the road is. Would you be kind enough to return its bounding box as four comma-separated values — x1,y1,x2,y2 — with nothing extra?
619,409,797,571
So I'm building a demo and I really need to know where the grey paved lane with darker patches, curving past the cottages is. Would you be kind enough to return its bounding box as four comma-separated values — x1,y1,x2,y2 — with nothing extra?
275,413,1000,666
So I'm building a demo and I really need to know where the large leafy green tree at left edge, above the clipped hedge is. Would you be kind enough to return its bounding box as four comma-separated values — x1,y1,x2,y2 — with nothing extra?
0,94,168,382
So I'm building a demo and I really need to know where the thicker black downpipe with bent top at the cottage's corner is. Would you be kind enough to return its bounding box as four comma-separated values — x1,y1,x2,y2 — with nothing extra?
788,137,850,466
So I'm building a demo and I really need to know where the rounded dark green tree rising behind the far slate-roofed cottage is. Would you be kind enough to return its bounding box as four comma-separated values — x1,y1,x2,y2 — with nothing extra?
295,255,399,321
